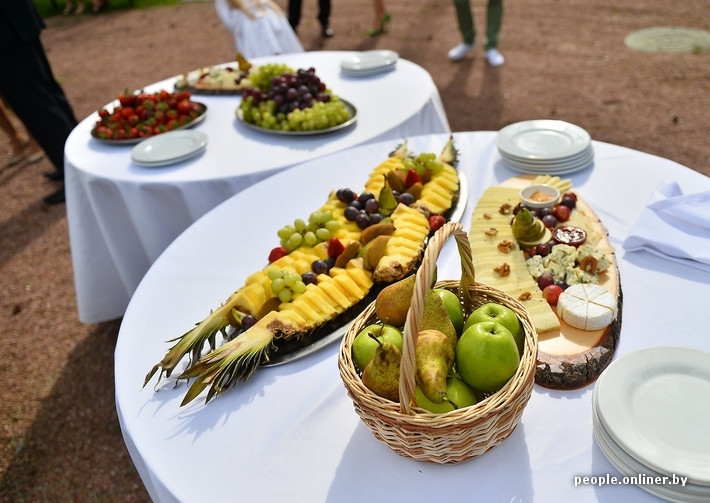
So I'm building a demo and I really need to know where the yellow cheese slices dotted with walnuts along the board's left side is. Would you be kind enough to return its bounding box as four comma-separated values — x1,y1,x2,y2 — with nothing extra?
469,186,560,333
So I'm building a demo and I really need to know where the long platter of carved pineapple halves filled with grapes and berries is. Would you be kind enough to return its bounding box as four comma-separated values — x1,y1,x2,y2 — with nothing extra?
144,138,467,405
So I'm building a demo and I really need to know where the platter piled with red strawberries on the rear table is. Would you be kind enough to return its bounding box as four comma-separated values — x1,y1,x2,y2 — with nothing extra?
91,90,207,145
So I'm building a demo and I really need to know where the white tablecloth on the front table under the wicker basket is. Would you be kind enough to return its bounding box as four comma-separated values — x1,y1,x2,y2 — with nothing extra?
115,132,710,503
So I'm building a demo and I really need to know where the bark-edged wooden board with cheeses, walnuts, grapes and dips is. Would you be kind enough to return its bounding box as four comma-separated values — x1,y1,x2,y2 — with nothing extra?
469,175,623,389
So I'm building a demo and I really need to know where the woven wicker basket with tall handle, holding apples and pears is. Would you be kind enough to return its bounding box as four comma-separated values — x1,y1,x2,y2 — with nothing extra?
338,223,537,464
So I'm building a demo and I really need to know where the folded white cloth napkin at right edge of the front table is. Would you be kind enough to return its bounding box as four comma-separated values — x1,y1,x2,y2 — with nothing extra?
623,182,710,272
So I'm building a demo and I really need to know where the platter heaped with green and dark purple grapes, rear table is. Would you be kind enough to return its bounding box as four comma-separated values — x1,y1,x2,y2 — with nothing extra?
236,63,357,136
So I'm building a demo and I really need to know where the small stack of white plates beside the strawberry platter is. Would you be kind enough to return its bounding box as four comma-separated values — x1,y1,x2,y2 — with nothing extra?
131,130,207,167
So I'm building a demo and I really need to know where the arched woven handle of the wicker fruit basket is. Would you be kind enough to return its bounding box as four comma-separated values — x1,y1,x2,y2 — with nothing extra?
399,222,475,414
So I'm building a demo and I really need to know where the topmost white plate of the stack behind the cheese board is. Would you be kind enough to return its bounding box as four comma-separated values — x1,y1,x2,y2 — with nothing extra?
495,119,592,160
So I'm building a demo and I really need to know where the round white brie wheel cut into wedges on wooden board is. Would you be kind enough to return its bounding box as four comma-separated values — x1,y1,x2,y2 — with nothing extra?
557,283,618,330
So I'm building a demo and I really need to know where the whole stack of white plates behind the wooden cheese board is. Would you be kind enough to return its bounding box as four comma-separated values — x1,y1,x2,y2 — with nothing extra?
496,119,594,175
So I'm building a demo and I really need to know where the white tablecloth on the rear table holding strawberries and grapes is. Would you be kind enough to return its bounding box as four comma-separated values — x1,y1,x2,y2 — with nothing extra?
65,52,450,323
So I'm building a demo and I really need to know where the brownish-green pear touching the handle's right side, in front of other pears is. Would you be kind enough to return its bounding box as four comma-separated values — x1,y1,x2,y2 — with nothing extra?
414,329,456,403
